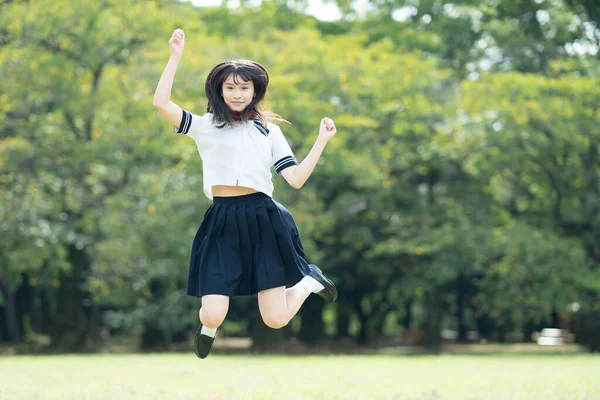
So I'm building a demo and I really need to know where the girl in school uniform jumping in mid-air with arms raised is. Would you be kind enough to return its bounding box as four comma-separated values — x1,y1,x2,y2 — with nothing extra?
153,29,337,358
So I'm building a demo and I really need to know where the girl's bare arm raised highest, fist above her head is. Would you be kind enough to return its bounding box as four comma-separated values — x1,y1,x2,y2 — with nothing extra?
152,29,185,128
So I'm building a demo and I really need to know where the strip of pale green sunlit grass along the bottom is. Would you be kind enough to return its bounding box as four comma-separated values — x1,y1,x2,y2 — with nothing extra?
0,353,600,400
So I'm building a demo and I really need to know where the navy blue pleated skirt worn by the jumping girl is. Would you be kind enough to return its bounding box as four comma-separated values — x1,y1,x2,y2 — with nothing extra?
187,193,310,297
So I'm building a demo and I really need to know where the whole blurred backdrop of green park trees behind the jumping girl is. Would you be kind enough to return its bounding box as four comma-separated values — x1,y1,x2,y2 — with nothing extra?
0,0,600,353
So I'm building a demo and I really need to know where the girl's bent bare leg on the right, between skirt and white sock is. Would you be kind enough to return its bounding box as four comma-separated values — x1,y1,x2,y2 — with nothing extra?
258,283,310,329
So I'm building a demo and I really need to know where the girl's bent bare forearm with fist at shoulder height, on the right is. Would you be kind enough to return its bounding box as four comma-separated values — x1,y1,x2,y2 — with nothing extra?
281,118,337,189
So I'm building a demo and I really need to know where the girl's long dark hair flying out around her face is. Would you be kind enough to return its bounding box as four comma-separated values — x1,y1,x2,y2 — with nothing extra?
204,60,289,128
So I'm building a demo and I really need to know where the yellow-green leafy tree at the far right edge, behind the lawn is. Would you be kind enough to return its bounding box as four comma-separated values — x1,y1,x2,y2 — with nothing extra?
456,73,600,340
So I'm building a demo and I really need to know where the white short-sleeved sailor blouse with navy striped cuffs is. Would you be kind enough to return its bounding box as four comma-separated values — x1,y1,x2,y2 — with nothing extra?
174,110,298,200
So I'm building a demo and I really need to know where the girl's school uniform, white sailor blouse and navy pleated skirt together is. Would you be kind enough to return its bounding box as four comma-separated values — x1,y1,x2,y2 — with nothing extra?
175,110,310,297
